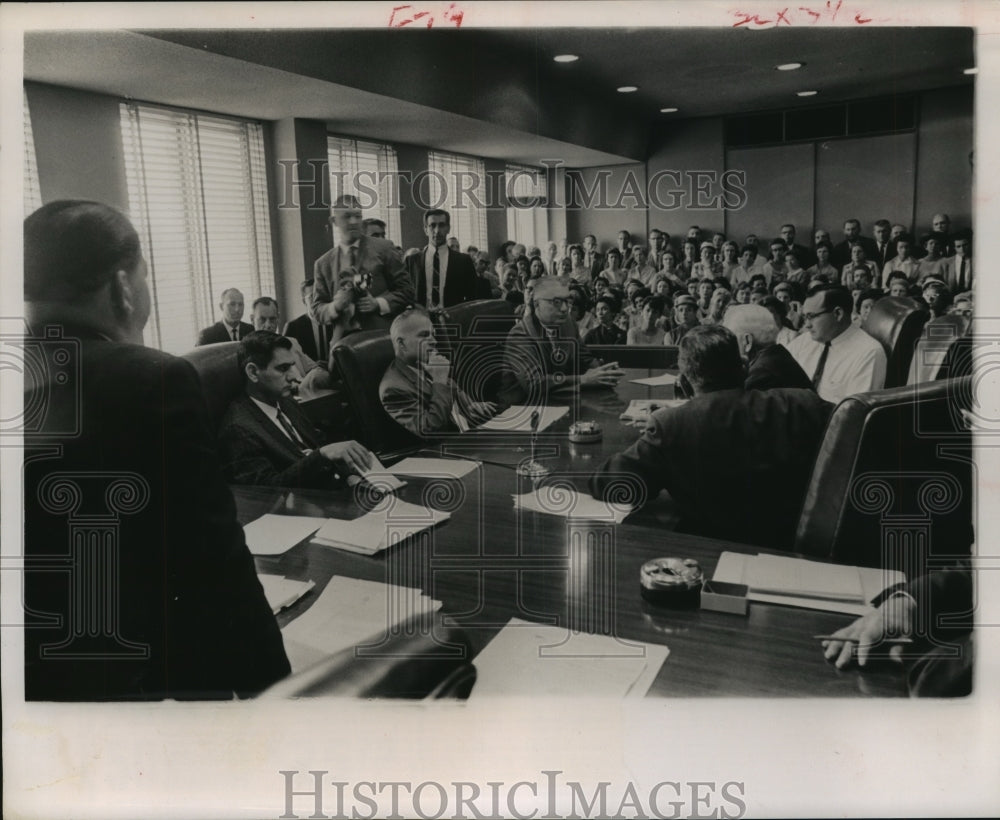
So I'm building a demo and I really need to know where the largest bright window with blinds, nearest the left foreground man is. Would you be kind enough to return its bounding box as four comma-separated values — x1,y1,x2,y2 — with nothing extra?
121,103,274,353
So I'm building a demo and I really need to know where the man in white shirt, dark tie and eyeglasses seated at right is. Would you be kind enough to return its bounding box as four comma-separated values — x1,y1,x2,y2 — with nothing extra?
788,285,886,404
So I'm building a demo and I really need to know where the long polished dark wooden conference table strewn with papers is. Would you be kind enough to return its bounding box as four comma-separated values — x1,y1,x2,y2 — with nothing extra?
233,369,906,697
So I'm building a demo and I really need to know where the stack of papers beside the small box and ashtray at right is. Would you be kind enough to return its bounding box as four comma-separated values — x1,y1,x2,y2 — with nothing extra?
713,552,906,615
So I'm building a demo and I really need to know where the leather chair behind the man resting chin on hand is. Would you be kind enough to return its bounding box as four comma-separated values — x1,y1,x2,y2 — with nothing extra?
333,330,420,455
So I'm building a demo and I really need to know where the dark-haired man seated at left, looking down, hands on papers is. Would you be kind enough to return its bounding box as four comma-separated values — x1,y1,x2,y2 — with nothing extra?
219,330,372,489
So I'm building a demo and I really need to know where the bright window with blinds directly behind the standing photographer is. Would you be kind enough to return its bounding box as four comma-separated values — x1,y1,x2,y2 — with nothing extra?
326,137,402,243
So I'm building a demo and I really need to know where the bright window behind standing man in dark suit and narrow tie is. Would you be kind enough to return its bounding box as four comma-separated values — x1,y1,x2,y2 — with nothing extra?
420,151,487,250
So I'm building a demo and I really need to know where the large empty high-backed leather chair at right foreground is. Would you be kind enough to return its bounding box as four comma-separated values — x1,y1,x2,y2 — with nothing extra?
794,376,974,574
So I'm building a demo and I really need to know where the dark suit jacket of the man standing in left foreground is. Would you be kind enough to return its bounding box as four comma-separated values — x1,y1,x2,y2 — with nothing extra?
24,328,289,700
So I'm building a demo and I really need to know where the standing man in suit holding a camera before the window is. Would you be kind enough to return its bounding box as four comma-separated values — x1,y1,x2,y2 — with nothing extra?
309,194,414,344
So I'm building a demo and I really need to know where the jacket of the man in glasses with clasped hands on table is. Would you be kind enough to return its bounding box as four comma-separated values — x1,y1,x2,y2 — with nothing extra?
499,315,597,405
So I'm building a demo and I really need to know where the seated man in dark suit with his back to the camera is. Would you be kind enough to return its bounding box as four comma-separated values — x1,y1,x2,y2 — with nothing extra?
590,325,831,549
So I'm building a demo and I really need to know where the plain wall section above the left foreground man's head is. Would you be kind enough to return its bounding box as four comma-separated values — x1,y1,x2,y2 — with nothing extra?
24,82,128,212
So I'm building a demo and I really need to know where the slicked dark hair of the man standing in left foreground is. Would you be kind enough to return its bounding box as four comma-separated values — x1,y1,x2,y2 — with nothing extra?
24,199,142,302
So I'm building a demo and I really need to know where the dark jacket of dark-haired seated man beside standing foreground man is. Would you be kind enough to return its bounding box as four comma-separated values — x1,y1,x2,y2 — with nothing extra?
219,393,342,489
